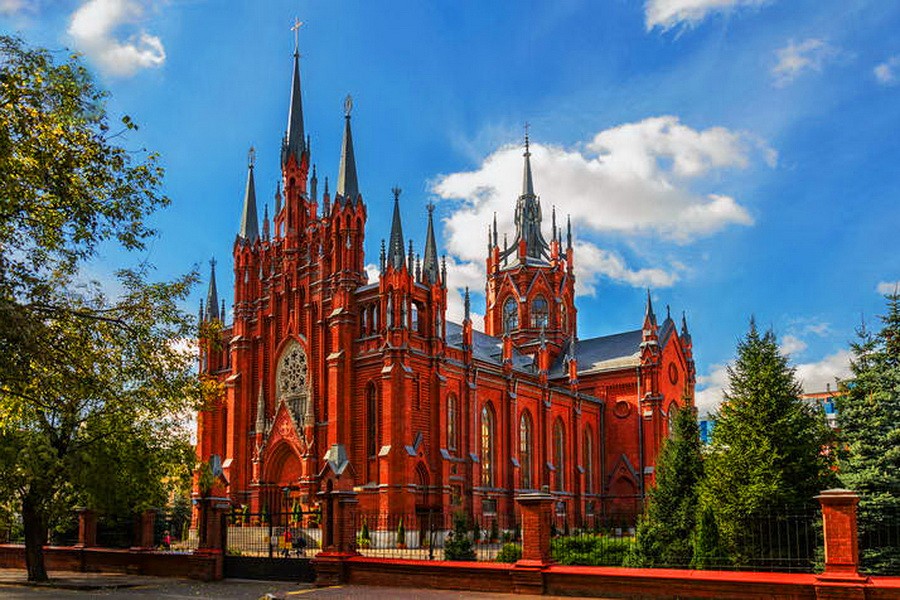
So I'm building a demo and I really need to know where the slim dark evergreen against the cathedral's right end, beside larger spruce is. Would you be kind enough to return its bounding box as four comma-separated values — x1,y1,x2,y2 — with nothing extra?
626,406,703,567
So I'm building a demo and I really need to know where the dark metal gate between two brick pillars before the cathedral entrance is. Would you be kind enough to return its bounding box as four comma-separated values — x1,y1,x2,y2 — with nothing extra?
224,507,322,582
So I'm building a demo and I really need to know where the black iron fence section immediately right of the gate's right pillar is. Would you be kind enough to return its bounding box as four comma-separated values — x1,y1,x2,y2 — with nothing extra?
354,511,522,562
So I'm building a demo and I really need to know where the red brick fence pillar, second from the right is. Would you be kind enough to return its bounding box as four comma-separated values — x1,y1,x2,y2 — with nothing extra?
513,492,554,594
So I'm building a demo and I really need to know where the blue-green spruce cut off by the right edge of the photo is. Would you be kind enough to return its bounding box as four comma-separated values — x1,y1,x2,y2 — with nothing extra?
837,292,900,570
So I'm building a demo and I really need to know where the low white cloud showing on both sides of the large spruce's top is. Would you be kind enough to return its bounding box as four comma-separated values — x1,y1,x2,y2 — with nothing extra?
696,346,852,416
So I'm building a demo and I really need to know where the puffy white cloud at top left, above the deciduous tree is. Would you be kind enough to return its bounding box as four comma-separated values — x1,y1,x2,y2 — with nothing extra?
68,0,166,77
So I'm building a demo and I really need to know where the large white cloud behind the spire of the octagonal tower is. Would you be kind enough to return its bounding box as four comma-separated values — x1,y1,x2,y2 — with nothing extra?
432,116,776,286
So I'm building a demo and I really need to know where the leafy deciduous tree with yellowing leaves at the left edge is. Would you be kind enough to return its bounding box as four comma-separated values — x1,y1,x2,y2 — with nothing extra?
0,36,199,581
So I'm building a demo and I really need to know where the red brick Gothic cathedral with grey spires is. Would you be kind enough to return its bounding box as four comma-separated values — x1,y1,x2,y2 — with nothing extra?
197,43,695,521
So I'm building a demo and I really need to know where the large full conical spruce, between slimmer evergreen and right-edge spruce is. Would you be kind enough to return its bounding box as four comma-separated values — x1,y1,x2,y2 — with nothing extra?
701,319,833,565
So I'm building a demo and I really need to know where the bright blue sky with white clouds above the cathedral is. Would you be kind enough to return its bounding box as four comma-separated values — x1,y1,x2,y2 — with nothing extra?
0,0,900,406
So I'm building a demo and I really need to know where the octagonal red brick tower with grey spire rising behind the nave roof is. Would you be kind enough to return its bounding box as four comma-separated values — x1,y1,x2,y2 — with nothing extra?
484,133,576,358
